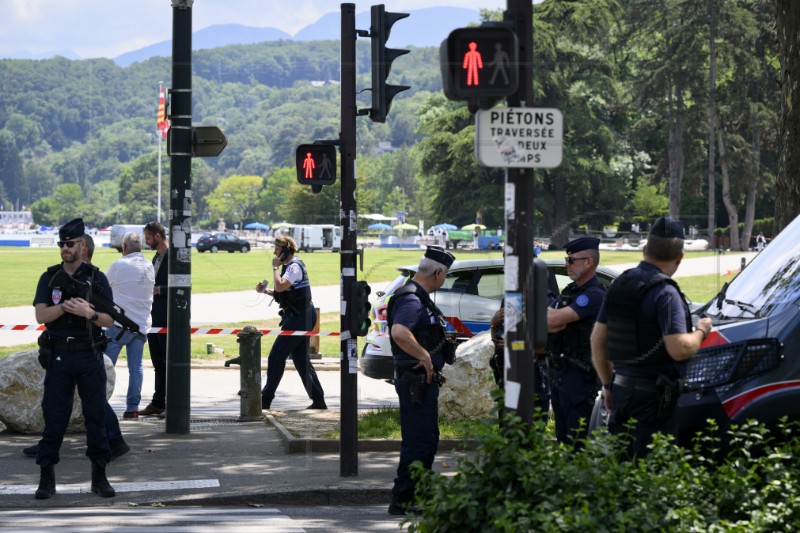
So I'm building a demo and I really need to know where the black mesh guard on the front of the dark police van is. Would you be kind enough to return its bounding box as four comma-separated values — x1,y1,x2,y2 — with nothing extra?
684,338,783,391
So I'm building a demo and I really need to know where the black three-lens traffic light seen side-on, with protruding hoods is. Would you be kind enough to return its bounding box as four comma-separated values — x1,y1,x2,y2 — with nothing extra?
369,4,410,122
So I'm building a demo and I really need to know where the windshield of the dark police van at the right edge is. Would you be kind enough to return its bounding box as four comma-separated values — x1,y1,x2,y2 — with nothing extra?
706,217,800,318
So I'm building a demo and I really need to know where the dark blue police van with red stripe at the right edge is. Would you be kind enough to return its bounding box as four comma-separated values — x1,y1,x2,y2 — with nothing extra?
590,216,800,445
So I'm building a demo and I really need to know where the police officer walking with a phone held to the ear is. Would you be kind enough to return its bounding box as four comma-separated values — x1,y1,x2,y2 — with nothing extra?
256,235,328,409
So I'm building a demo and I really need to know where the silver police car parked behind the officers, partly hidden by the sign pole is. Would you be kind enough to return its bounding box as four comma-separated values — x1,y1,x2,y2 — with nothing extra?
361,259,619,381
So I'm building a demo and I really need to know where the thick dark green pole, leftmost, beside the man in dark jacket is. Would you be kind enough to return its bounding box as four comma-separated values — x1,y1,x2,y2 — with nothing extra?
166,0,194,434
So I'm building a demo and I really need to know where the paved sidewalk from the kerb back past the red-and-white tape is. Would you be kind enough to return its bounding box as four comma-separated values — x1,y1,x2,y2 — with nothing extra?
0,365,460,508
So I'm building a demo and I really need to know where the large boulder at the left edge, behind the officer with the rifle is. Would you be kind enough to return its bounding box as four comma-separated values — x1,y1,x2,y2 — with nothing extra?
0,349,116,434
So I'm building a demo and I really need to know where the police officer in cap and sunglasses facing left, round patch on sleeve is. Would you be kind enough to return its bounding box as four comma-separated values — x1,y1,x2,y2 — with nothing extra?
547,237,605,442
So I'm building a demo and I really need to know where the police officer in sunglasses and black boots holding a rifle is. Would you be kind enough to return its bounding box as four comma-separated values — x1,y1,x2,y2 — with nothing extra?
33,218,115,499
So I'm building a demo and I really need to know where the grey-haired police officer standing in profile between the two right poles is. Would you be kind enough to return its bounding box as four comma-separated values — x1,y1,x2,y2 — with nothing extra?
387,246,455,515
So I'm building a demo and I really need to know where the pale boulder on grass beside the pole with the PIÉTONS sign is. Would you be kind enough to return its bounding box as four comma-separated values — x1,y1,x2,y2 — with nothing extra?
439,331,497,420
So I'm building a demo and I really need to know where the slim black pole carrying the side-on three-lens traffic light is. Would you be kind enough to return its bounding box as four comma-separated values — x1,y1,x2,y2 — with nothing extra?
339,4,358,477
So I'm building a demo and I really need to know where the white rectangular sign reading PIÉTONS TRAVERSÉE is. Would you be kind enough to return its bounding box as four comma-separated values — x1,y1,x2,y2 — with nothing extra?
475,107,564,168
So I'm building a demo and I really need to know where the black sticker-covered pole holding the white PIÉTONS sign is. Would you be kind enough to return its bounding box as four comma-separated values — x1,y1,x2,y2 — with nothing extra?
505,0,537,424
